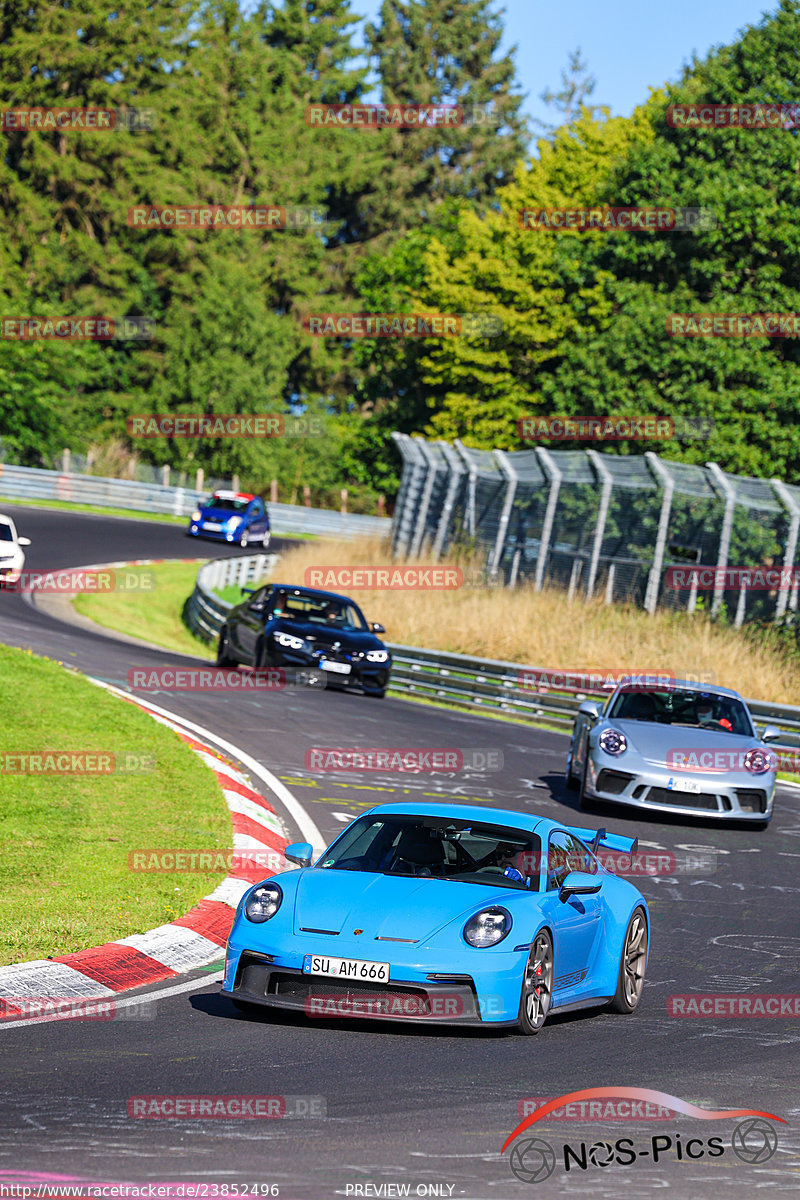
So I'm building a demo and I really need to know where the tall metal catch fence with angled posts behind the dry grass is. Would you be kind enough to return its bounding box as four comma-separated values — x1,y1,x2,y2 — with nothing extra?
392,433,800,625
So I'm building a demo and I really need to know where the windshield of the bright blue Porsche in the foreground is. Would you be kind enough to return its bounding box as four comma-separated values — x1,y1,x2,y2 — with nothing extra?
319,815,541,892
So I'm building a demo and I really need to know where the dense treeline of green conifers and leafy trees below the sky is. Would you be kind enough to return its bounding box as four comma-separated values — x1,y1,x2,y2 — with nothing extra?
0,0,800,508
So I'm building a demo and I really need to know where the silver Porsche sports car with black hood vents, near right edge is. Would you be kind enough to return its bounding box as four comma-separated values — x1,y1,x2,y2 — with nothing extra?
566,679,781,827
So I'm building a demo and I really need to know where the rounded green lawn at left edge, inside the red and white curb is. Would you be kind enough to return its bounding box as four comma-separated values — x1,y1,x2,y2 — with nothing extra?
0,646,233,964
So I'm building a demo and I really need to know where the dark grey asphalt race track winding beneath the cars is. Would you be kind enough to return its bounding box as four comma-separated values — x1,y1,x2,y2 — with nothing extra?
0,502,800,1200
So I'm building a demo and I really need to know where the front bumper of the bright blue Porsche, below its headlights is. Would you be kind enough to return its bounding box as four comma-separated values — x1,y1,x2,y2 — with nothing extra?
222,922,529,1028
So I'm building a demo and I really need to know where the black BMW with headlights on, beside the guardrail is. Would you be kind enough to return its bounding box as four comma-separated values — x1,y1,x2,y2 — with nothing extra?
217,583,392,697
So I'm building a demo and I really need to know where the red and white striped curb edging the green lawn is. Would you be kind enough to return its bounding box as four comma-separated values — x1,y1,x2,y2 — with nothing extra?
0,680,299,1015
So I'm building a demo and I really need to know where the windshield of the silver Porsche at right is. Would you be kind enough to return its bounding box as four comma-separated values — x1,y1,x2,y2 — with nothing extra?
608,688,754,737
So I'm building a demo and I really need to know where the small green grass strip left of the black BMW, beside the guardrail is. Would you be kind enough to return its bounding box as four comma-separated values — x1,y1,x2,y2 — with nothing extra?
73,563,215,661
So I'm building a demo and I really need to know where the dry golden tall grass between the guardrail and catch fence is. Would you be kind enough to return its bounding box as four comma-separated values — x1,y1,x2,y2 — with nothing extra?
276,539,800,704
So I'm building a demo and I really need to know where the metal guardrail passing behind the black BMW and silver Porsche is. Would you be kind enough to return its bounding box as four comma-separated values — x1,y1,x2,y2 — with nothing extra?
186,554,800,750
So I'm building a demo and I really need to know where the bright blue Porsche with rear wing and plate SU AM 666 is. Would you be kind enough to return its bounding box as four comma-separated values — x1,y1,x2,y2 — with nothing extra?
223,803,650,1033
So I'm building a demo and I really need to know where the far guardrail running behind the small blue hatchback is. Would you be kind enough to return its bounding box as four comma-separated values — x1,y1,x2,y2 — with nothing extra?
0,463,391,538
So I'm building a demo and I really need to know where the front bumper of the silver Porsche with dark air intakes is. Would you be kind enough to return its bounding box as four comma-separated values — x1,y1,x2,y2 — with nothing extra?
584,751,775,822
